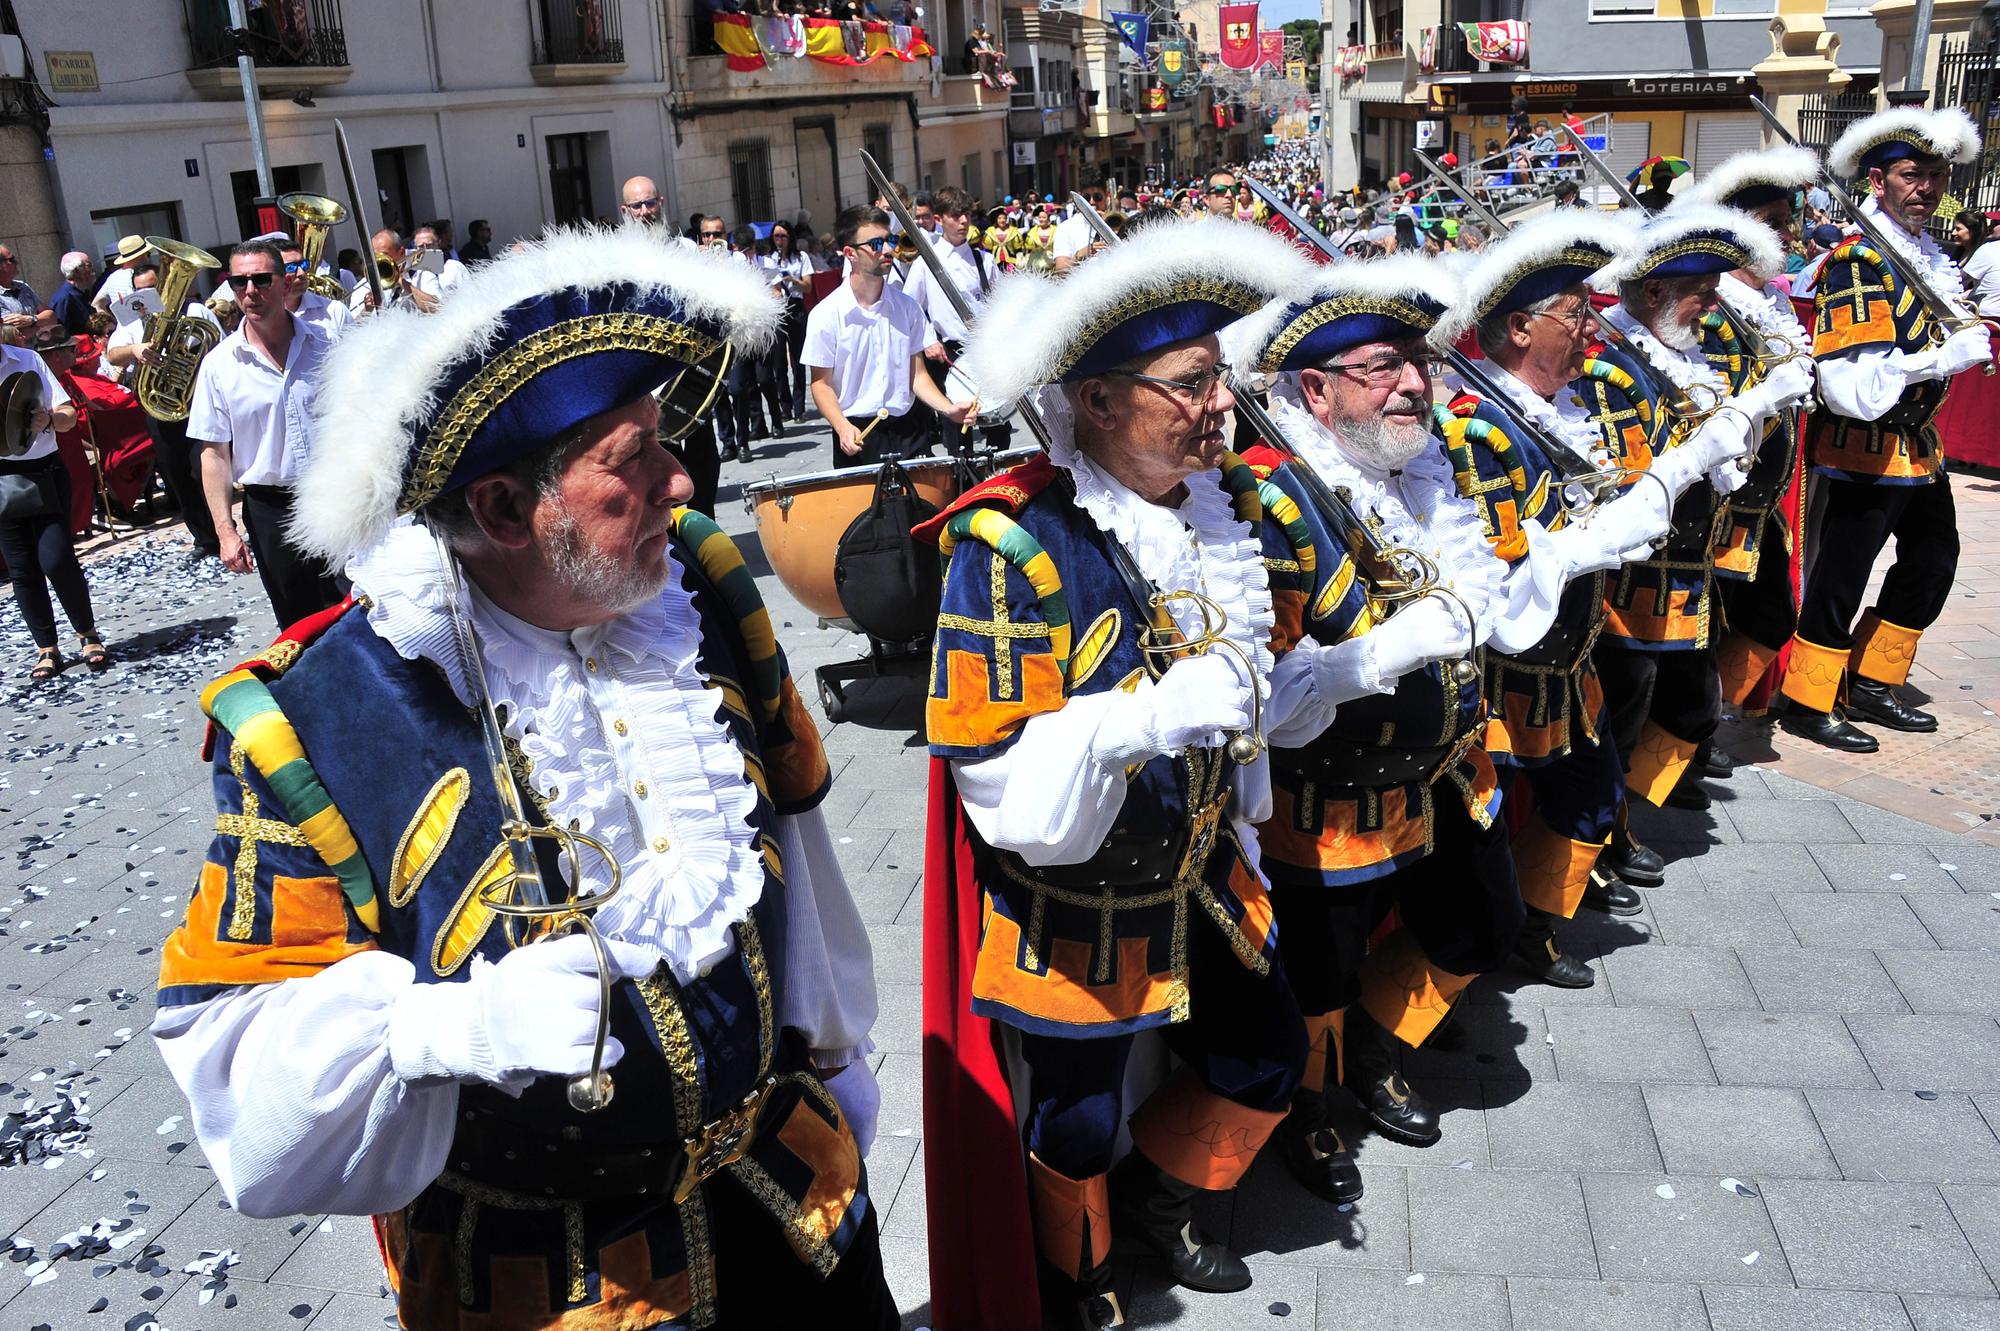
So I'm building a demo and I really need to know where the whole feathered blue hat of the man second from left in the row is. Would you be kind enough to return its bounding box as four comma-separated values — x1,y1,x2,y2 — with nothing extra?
962,218,1312,406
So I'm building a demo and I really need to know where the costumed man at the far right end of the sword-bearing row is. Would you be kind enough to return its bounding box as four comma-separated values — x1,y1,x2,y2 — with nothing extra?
1778,106,1992,753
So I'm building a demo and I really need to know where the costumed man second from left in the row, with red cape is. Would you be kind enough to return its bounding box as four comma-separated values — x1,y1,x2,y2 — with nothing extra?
918,220,1308,1327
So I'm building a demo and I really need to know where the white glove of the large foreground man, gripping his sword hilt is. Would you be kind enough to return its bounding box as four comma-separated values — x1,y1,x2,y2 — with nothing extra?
388,933,660,1093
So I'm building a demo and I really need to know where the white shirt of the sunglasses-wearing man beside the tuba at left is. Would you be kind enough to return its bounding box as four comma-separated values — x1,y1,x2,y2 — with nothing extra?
188,318,328,486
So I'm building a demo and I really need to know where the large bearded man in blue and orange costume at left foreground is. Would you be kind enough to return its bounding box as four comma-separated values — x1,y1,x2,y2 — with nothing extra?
154,228,896,1331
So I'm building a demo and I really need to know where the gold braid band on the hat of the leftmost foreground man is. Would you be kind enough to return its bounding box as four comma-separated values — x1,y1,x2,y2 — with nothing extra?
396,312,722,514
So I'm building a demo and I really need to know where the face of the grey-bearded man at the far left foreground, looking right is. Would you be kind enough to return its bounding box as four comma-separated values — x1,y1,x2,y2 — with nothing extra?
532,396,694,620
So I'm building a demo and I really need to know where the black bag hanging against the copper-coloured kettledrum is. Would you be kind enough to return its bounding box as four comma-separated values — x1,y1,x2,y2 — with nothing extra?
834,462,944,642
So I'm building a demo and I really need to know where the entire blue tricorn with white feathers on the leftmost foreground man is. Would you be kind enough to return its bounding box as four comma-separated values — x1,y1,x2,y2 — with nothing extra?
288,224,784,564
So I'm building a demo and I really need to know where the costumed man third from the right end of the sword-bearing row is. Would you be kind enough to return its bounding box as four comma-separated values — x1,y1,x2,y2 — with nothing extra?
1572,208,1812,807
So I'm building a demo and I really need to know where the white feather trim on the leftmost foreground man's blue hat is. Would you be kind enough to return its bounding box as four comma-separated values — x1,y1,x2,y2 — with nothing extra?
286,224,784,564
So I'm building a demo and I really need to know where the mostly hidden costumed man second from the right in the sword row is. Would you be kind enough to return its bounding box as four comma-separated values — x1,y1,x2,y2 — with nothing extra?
1674,144,1820,735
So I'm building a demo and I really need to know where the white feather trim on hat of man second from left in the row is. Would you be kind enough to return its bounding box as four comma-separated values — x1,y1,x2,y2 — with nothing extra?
962,218,1314,404
